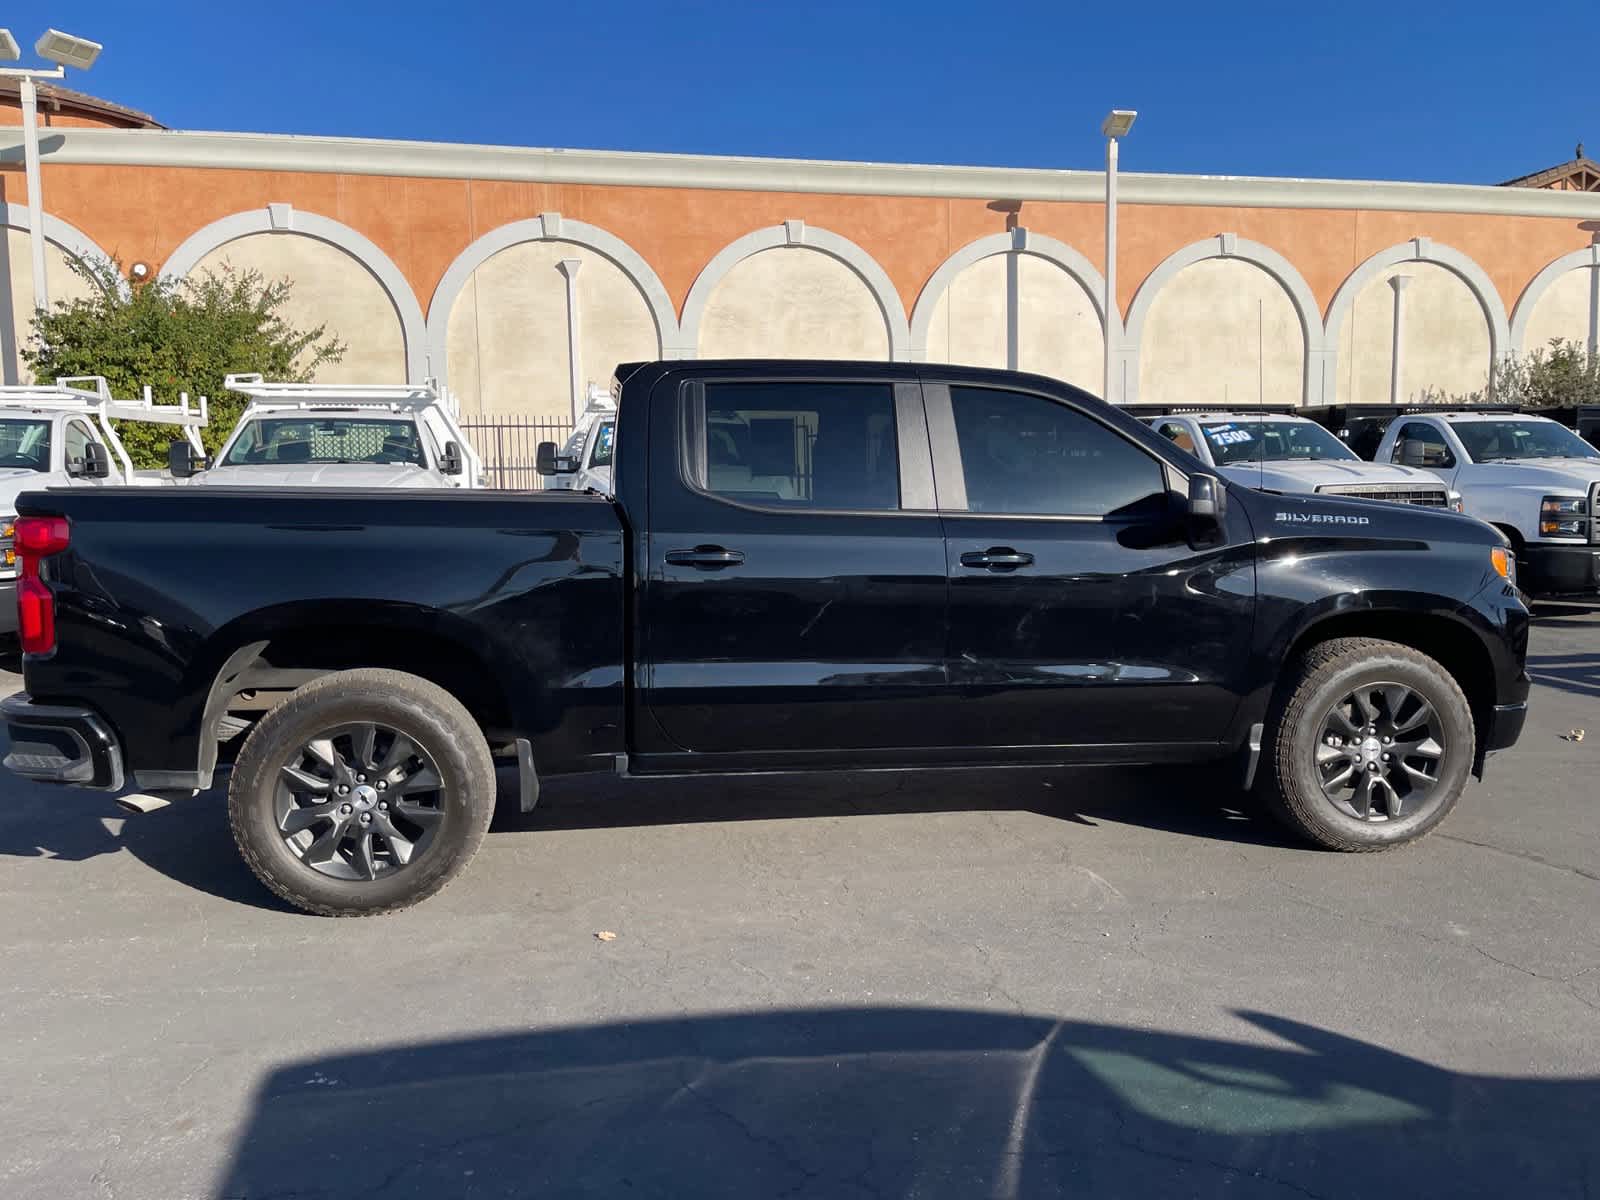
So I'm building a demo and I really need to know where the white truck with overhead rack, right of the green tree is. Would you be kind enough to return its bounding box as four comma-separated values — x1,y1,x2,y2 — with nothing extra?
168,374,483,488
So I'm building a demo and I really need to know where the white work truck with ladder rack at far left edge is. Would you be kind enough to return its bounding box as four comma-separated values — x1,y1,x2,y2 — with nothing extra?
0,374,206,634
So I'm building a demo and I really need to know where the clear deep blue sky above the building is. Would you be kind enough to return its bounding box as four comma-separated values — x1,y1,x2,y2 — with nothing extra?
9,0,1600,182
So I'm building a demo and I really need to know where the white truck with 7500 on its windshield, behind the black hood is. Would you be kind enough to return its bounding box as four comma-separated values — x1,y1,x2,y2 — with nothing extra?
1128,408,1461,512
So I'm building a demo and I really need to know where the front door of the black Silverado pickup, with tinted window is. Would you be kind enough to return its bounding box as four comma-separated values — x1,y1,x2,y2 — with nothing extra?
925,376,1254,757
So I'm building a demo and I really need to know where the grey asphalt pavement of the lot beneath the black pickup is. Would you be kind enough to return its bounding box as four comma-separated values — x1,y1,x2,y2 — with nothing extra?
0,620,1600,1200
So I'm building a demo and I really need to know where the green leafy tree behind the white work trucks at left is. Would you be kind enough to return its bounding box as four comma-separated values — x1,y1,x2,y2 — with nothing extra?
22,259,346,467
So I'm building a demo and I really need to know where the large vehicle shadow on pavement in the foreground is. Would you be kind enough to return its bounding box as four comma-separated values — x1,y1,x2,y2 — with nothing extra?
218,1008,1600,1200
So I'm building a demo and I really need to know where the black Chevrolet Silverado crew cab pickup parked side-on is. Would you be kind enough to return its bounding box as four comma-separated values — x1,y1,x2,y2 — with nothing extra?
0,362,1528,915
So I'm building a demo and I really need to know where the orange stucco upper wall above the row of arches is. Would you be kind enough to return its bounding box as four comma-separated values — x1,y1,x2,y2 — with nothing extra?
0,157,1592,324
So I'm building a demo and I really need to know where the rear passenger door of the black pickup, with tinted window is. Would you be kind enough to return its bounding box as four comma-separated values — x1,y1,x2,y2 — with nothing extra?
638,366,947,763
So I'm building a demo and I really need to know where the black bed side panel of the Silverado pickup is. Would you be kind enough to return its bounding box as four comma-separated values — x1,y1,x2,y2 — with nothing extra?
18,488,626,787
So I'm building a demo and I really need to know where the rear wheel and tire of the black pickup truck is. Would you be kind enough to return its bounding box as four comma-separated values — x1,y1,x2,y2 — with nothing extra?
227,669,494,917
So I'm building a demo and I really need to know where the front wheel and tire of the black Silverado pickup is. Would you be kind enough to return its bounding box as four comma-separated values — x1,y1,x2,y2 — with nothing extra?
1259,638,1477,851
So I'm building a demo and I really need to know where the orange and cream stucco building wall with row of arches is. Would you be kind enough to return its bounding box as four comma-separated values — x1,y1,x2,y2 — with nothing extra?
0,130,1600,418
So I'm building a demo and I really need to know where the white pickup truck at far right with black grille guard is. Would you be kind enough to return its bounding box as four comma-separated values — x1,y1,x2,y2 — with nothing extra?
1373,410,1600,598
